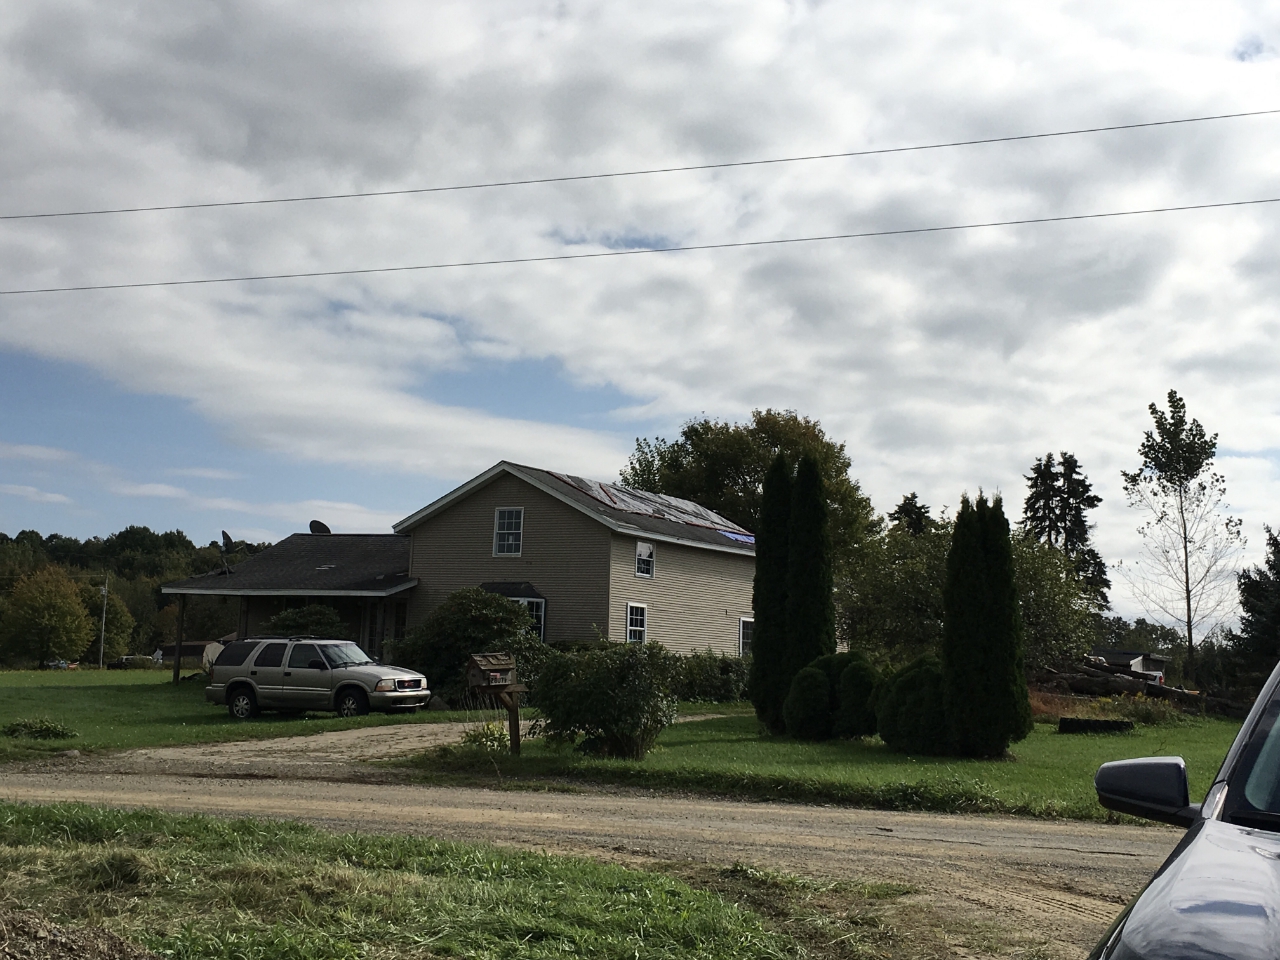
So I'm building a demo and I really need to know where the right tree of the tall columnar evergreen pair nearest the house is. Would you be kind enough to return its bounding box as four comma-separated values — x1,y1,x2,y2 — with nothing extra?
786,454,836,687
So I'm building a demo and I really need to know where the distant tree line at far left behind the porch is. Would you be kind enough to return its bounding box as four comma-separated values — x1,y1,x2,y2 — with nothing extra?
0,526,268,664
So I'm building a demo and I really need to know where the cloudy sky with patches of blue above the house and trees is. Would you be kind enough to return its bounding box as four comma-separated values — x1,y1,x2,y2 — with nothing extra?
0,0,1280,619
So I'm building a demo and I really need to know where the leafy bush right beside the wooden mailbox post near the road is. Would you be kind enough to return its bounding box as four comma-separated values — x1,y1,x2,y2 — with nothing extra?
534,644,681,760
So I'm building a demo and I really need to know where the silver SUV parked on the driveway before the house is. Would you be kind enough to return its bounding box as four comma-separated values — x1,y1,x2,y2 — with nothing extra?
205,636,431,719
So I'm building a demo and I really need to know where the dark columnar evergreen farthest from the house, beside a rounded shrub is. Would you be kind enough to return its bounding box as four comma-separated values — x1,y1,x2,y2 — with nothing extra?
942,494,1032,756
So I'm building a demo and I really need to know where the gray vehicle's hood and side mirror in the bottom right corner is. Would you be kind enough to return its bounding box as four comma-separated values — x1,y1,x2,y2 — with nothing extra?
1089,666,1280,960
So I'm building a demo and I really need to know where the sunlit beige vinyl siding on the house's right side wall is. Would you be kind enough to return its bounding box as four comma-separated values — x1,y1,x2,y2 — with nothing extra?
609,534,755,655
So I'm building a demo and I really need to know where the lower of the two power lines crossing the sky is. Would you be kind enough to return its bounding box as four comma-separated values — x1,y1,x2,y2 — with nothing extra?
0,197,1280,297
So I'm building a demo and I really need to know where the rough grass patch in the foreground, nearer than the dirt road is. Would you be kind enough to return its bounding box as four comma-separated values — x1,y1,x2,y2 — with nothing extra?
0,804,798,960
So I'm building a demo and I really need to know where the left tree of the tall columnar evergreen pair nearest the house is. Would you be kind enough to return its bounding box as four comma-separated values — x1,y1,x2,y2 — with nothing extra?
748,453,795,733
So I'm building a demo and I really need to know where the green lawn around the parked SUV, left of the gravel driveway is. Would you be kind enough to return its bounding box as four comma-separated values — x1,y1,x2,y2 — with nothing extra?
0,671,519,763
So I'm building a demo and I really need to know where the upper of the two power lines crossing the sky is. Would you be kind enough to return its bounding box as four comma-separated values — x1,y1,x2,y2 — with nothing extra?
0,109,1280,220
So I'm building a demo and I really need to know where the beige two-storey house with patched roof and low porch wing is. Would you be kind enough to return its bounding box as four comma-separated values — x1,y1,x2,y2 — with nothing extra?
164,461,755,654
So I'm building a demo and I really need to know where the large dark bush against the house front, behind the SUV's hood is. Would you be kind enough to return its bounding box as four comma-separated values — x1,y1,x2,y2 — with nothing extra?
388,586,549,705
